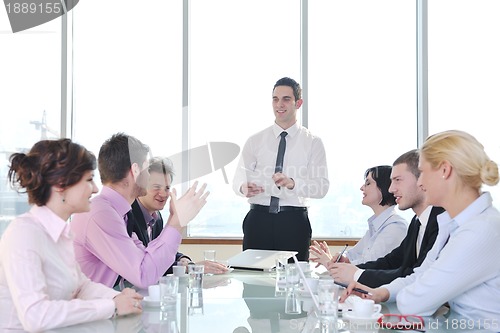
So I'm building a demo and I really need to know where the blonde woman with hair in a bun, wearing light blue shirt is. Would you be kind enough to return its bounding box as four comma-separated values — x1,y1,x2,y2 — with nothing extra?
341,131,500,324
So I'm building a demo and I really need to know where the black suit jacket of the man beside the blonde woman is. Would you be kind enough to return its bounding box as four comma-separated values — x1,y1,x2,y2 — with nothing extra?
357,207,444,288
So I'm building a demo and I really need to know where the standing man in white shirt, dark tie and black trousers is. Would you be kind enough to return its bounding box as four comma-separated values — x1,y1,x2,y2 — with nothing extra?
233,77,330,260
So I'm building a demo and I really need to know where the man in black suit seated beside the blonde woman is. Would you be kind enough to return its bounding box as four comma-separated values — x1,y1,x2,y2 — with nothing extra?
311,150,444,288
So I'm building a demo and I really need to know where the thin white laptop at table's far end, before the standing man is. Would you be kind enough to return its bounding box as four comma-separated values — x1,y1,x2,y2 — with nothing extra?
228,249,297,272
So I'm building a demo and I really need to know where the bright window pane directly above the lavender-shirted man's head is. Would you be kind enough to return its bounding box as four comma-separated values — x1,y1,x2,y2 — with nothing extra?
73,0,183,176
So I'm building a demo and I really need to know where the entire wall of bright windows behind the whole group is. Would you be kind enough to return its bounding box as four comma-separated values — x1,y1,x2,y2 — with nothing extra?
4,0,500,238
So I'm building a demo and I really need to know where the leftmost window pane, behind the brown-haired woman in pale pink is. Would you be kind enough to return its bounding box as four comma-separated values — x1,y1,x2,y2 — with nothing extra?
0,10,61,235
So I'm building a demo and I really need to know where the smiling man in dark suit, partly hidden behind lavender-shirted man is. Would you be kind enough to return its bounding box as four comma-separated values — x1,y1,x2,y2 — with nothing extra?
127,157,227,274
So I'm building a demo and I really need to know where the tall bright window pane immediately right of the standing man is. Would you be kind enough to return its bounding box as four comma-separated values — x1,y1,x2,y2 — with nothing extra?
308,0,417,237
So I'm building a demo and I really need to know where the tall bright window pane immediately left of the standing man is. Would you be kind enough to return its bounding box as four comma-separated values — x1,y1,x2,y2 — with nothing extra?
189,0,300,237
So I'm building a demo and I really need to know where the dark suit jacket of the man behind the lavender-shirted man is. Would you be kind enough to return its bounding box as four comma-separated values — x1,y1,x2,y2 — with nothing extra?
127,200,191,274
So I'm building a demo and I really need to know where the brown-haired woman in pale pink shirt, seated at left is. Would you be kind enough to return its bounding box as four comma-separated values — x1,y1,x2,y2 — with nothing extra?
0,139,142,332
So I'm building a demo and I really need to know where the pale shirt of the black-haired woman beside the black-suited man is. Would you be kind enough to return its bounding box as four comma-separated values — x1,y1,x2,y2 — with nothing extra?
346,206,408,265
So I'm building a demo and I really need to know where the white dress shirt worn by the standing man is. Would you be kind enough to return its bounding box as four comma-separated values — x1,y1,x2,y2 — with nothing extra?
233,123,330,207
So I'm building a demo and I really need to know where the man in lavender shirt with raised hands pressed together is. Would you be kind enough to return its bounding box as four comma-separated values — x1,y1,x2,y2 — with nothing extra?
71,133,209,289
